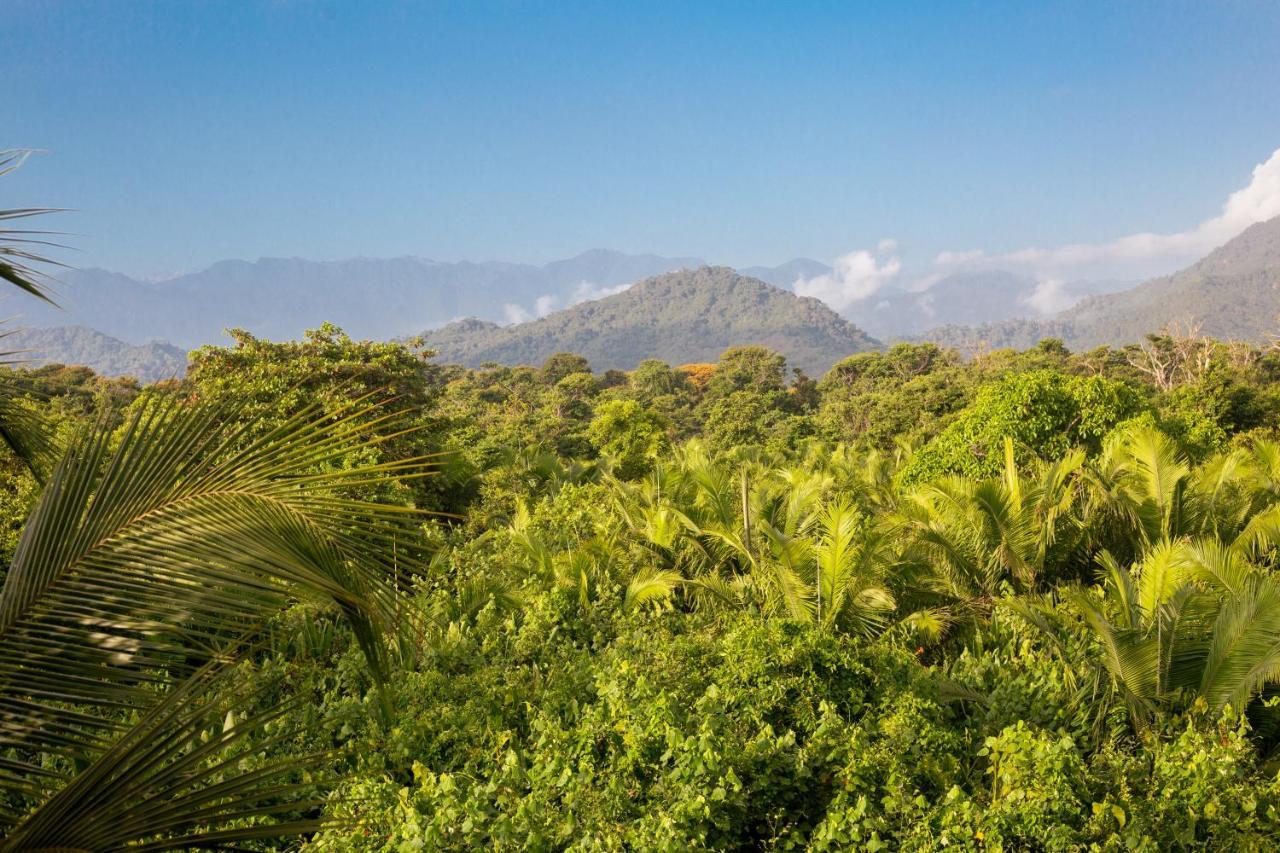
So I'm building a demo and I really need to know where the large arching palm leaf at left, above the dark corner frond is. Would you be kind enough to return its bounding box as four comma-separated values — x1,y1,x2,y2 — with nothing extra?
0,391,429,849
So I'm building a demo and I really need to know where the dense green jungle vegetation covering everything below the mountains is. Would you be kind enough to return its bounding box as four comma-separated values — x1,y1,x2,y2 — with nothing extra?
12,158,1280,853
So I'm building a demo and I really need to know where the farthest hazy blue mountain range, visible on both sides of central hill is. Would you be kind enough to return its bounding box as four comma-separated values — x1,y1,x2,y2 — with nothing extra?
12,250,1121,348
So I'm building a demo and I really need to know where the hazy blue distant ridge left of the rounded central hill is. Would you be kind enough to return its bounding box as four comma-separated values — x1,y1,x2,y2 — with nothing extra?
12,250,703,347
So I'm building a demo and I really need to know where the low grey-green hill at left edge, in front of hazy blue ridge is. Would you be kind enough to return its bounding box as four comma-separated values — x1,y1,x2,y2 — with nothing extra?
0,325,187,382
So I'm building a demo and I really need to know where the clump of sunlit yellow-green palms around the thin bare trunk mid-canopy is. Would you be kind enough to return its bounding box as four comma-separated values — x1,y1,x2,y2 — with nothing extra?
614,443,896,635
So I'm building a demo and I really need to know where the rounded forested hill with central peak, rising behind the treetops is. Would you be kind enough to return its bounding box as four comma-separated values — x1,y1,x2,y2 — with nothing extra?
425,266,877,375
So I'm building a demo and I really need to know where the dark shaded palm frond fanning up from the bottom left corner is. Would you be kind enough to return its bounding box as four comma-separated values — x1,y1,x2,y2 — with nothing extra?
0,661,329,853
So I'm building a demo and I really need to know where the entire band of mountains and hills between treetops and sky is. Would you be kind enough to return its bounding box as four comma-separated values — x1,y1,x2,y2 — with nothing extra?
8,213,1280,379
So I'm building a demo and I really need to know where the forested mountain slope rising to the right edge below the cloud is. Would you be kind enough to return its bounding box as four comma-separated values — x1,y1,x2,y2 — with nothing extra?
919,218,1280,351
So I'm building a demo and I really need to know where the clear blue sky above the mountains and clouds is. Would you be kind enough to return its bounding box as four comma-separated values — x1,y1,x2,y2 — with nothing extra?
0,0,1280,275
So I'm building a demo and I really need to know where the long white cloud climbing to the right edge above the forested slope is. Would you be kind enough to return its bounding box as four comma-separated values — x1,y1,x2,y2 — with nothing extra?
934,149,1280,279
